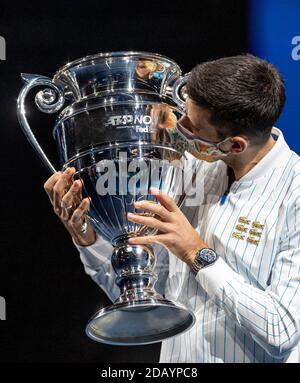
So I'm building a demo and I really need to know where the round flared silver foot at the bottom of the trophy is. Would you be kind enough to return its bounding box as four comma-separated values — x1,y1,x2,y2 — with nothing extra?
86,294,196,346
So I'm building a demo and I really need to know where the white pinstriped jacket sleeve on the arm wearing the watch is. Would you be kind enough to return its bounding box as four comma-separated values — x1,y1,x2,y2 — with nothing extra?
196,196,300,358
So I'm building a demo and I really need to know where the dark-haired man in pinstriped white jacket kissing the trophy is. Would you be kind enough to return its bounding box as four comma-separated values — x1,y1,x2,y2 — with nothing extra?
45,55,300,363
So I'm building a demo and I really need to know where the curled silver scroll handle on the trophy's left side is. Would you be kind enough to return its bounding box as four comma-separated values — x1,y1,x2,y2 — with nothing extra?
17,73,65,173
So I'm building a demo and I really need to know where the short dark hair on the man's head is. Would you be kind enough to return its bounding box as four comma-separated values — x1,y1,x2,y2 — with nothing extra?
186,54,285,144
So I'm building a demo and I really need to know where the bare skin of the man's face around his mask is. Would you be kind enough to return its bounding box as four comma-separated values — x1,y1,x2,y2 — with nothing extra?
179,97,230,162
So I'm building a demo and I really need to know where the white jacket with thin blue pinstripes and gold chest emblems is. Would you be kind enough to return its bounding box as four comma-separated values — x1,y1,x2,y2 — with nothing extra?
77,128,300,363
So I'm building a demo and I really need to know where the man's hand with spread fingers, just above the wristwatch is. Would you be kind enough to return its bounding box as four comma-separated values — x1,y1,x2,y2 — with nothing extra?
128,188,208,266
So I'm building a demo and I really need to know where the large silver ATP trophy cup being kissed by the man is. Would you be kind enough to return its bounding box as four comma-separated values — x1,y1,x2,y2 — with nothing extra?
18,52,195,345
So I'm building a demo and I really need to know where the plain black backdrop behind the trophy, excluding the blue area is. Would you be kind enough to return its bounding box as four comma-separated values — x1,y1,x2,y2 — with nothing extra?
0,0,247,362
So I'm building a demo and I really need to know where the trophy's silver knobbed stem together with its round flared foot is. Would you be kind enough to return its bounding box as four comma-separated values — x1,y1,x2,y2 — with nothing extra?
86,237,195,346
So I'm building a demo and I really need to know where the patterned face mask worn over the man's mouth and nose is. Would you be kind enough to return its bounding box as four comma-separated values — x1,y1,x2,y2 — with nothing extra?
177,123,231,160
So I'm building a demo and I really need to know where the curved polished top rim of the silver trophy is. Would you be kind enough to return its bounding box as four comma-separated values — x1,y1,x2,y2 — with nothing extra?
54,50,182,80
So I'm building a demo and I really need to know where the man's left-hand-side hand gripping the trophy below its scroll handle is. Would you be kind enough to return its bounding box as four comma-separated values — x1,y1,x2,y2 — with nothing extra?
44,168,96,246
